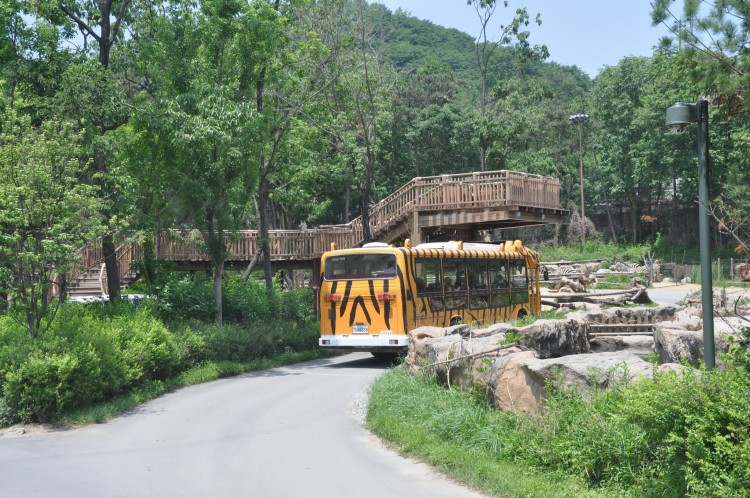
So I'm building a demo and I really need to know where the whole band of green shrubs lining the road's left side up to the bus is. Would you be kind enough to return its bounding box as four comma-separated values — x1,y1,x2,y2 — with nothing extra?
0,274,318,425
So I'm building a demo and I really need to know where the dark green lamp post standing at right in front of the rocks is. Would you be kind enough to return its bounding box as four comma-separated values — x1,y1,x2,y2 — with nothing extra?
665,100,716,370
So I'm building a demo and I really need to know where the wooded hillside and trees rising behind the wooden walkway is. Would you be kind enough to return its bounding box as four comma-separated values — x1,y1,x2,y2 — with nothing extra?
0,0,750,312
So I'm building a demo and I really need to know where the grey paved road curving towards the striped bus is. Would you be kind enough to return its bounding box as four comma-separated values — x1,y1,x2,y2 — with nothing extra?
0,354,488,498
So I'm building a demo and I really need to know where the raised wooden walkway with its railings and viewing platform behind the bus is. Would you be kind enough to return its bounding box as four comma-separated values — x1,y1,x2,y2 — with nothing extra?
71,170,565,296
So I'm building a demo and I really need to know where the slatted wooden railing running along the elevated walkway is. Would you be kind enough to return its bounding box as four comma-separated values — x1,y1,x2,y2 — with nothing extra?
75,170,560,274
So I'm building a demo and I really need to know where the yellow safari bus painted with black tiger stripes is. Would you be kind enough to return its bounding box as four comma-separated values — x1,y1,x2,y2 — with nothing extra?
319,240,540,355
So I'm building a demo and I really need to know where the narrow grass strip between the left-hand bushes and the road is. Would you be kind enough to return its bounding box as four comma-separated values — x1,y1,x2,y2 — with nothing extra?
60,351,325,426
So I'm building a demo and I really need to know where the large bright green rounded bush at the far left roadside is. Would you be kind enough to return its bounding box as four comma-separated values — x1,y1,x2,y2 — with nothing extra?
0,305,180,421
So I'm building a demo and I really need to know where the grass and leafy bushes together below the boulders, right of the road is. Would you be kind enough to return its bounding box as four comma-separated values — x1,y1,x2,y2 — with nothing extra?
368,353,750,497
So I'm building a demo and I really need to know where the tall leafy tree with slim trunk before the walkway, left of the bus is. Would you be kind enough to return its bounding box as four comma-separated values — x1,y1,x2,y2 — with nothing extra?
134,0,266,323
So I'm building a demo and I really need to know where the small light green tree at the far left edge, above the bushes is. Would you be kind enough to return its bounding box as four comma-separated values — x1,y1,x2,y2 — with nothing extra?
0,109,102,337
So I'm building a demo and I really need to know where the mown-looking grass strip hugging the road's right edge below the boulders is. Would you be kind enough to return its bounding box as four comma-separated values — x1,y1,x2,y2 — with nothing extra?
367,369,635,498
